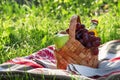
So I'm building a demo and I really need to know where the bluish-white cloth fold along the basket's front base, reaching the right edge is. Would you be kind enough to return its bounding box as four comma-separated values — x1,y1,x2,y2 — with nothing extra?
67,57,120,77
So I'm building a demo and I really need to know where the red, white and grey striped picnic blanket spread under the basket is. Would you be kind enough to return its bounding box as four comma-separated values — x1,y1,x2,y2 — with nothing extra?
0,40,120,80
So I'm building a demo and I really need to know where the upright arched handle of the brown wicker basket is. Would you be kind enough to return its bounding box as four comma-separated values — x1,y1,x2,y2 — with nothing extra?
69,15,81,39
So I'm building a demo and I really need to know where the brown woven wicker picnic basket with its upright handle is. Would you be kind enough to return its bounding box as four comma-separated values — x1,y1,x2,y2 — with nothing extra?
54,15,98,69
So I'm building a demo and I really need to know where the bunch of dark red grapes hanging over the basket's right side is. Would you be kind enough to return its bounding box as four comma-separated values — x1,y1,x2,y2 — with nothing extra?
66,22,101,55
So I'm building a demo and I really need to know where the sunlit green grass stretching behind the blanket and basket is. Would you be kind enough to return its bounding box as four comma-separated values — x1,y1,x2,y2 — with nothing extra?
0,0,120,63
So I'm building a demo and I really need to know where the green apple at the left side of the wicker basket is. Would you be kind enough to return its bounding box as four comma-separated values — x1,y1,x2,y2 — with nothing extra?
54,33,69,49
